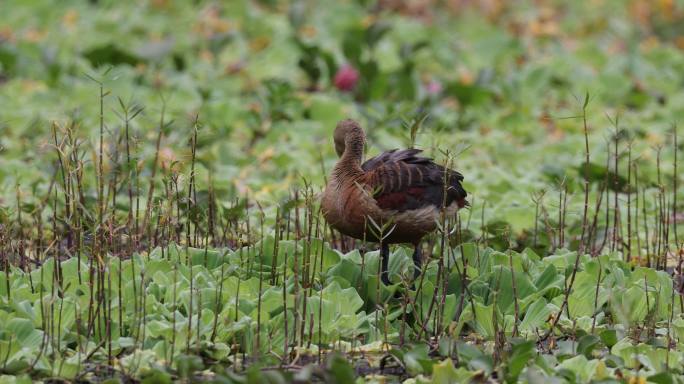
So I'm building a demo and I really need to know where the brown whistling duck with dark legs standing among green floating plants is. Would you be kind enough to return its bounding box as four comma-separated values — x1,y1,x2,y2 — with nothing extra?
321,119,468,285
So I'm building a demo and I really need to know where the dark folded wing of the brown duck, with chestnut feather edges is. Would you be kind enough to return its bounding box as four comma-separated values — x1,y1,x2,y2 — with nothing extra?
361,149,467,212
